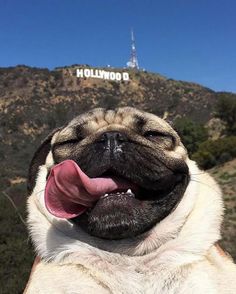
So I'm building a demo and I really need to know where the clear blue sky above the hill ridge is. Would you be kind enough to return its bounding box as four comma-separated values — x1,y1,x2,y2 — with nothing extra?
0,0,236,92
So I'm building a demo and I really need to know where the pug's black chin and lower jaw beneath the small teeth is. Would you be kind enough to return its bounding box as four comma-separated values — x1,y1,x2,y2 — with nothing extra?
71,177,188,240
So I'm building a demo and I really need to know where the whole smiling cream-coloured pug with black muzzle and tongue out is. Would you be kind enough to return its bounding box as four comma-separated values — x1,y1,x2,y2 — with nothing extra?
25,107,236,294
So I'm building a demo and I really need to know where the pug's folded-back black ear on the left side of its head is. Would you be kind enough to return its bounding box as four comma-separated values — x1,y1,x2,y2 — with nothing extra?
27,128,61,195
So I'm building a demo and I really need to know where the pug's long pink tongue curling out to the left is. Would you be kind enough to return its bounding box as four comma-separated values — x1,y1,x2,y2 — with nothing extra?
45,160,134,218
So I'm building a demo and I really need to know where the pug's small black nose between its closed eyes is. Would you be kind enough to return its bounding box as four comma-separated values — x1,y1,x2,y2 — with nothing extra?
97,131,128,149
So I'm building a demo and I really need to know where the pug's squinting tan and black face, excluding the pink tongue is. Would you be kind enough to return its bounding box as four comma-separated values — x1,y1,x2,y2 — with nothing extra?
29,107,189,239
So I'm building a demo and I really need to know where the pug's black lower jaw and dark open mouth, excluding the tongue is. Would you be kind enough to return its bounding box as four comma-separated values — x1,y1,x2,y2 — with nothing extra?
70,169,189,240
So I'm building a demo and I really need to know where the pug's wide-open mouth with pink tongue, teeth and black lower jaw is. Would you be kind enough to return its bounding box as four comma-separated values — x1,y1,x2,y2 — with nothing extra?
45,160,189,240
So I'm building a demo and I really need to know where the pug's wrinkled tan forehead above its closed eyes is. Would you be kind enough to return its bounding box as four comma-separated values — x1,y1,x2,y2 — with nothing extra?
53,107,178,141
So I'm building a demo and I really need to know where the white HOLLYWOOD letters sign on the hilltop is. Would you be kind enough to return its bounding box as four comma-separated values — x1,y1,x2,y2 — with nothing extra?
76,68,129,81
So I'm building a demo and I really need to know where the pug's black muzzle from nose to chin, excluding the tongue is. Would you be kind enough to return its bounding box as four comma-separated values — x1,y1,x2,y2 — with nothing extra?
67,132,189,239
